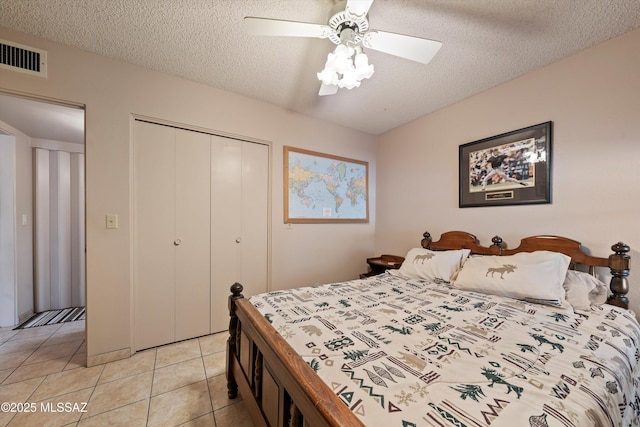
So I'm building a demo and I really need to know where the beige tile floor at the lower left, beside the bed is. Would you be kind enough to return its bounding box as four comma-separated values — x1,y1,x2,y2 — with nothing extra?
0,320,252,427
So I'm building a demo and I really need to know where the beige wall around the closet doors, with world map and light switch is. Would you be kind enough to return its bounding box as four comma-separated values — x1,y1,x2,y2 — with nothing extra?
0,28,376,362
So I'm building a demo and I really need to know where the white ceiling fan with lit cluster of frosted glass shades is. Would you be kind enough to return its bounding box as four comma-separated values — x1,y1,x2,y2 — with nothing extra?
244,0,442,95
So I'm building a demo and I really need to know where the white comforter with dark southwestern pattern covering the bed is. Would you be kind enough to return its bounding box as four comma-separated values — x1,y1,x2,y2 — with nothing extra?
250,274,640,427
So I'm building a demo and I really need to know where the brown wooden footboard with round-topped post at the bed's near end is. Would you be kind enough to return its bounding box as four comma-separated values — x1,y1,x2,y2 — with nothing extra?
226,283,363,427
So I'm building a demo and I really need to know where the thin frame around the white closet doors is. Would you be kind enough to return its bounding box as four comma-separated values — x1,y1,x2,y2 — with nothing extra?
129,114,273,354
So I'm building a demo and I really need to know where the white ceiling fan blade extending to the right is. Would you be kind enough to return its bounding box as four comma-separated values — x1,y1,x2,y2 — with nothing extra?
362,30,442,64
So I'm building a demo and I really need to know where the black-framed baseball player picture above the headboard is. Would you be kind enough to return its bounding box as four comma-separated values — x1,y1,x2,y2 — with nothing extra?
459,122,552,208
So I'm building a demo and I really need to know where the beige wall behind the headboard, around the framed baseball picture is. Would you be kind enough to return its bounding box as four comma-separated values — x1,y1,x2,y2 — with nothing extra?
376,26,640,314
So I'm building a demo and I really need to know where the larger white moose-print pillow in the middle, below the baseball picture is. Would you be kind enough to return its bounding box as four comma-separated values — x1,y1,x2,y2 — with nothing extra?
453,251,571,307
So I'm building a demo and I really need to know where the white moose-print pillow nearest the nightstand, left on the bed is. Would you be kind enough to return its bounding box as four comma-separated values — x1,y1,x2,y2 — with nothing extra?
392,248,471,282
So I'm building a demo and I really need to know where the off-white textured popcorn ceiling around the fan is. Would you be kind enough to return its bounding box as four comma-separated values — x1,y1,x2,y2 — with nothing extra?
0,0,640,135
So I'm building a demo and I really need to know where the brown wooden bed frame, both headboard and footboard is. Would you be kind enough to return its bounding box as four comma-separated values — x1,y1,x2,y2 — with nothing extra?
226,231,629,427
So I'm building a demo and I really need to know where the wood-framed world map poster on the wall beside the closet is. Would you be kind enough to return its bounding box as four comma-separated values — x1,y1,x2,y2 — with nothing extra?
284,146,369,224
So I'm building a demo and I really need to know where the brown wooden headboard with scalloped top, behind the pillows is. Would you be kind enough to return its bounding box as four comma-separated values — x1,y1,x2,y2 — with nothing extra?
420,231,630,309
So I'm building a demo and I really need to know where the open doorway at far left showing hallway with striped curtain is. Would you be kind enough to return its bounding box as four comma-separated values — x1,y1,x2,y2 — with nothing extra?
0,92,85,326
